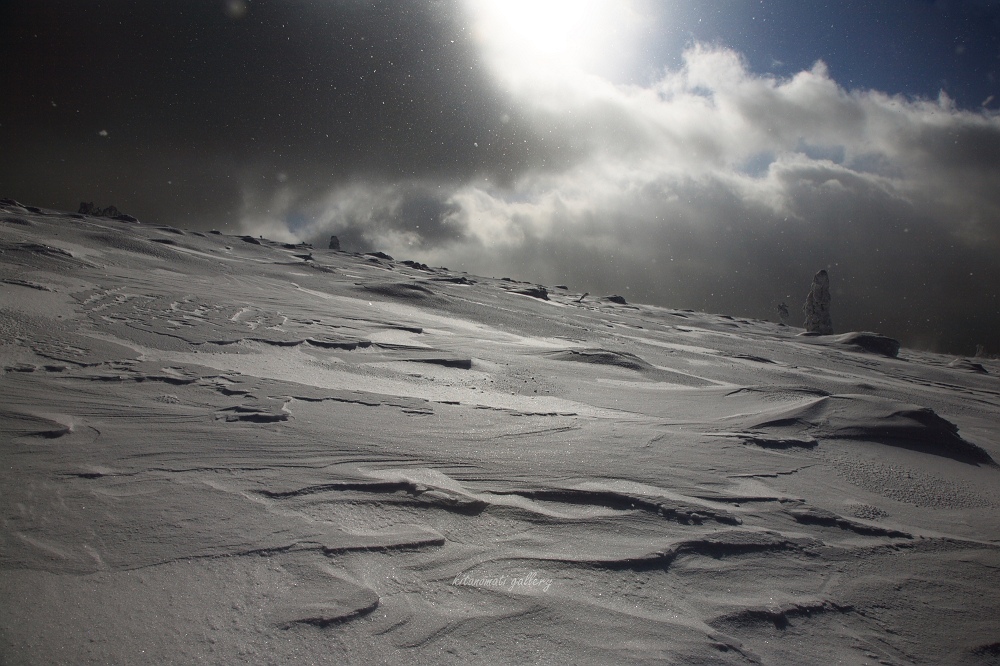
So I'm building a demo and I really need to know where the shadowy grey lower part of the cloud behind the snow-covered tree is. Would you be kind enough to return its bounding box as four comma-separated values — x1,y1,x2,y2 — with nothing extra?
440,166,1000,353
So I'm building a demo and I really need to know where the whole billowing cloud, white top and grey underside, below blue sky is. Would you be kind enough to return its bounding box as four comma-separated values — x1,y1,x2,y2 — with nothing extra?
256,40,1000,350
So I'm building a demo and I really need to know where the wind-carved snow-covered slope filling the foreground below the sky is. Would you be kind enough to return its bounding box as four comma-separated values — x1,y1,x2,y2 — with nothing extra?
0,203,1000,664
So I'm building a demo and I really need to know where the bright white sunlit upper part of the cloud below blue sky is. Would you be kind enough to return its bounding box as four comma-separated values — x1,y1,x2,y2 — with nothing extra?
438,41,1000,253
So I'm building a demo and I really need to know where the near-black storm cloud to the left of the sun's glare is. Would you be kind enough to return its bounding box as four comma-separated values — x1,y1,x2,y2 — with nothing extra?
0,0,564,224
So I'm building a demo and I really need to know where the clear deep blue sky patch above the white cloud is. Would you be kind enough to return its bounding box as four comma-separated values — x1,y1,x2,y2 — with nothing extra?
632,0,1000,110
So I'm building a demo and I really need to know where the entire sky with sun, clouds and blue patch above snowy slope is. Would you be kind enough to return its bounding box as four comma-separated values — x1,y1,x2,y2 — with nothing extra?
0,0,1000,355
